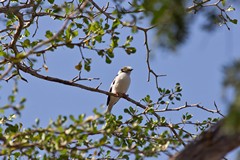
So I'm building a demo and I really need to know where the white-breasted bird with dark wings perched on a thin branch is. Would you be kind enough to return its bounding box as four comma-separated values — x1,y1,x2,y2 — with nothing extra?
107,66,133,113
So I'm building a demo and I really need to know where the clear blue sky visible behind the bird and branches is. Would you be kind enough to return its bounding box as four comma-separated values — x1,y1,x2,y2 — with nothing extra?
0,0,240,159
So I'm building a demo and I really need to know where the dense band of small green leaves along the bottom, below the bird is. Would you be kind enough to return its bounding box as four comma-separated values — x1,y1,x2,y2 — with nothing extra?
0,84,222,159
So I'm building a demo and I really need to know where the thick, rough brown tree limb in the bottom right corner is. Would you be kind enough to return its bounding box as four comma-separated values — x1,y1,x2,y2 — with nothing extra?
170,119,240,160
